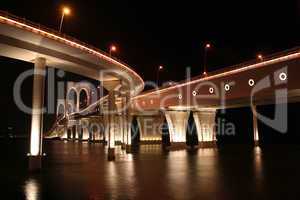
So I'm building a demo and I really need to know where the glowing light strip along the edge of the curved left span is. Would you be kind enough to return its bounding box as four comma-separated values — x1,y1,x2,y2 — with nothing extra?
0,16,144,87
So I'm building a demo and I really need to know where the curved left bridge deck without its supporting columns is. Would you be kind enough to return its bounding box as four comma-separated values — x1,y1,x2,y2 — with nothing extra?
0,12,144,95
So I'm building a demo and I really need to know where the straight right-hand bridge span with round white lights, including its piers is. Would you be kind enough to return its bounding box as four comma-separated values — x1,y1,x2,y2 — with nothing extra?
55,48,300,157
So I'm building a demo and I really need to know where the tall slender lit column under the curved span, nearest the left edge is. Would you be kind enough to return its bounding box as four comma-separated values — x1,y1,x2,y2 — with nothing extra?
29,58,46,171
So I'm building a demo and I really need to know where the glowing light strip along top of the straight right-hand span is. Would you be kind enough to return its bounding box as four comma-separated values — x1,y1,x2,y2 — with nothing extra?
132,52,300,100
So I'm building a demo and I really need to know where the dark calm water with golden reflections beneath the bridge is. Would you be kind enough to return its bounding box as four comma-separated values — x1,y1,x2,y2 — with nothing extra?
0,141,300,200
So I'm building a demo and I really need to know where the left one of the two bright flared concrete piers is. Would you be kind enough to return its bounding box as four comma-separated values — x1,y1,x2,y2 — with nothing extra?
165,111,190,146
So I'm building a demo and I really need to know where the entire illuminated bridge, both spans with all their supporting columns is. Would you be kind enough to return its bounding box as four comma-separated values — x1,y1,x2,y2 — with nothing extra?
0,10,300,169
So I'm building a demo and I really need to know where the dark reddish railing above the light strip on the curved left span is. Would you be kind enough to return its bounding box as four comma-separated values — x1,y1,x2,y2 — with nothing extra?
0,10,131,72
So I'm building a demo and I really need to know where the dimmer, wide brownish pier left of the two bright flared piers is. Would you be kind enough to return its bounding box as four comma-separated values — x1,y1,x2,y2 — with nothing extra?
137,115,164,144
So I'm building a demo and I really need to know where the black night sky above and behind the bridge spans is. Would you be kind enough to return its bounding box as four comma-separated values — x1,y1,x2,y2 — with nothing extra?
0,0,300,134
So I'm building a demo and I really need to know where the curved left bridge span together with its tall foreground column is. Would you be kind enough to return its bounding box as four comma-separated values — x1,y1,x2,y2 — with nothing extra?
0,11,144,169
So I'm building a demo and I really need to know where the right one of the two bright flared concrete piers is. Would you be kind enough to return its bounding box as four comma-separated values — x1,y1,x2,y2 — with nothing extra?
193,110,217,148
